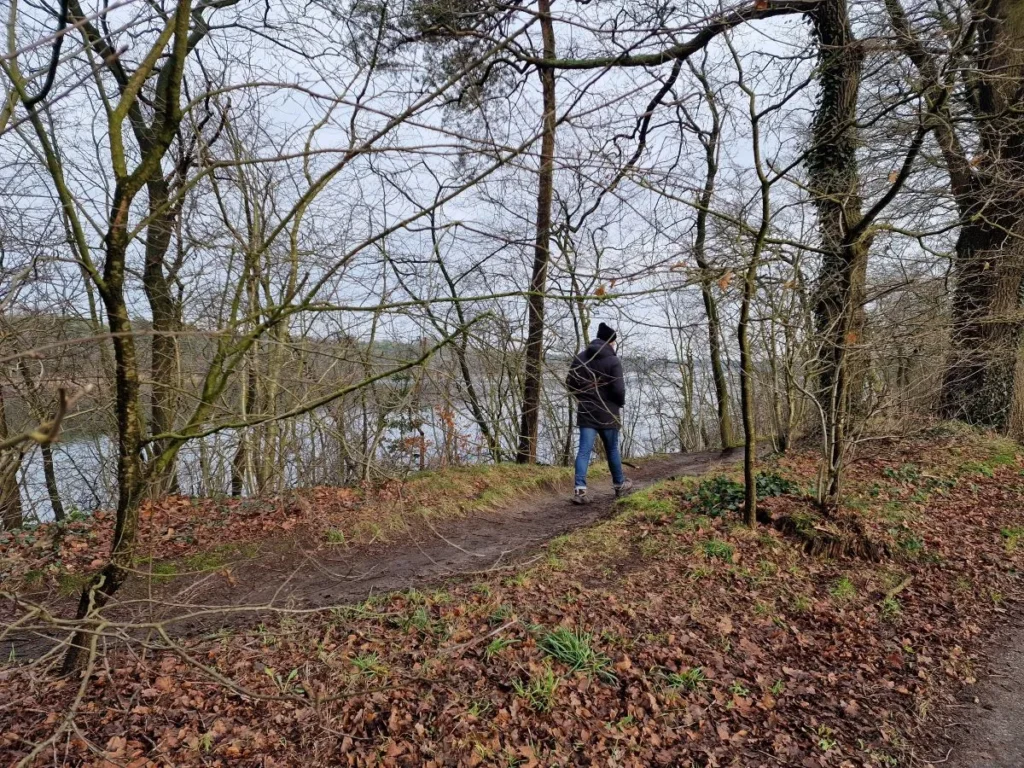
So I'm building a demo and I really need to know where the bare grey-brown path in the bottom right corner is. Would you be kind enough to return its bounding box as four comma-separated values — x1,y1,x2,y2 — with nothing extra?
934,621,1024,768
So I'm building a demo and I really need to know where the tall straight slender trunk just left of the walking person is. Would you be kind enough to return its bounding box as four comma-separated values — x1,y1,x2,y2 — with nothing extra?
516,0,556,464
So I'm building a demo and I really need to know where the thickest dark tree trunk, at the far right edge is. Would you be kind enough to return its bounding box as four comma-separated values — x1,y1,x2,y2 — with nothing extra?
886,0,1024,438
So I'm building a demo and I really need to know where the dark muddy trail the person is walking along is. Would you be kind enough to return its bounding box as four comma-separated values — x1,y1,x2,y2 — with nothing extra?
9,450,742,662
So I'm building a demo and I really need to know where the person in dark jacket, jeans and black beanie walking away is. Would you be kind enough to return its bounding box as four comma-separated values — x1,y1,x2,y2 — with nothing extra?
565,323,633,504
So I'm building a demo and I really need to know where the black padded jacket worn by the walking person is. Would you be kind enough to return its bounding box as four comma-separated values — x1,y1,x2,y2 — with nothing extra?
565,339,626,429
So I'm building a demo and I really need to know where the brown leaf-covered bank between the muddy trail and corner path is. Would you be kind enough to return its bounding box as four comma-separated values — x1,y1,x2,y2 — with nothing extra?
0,431,1024,768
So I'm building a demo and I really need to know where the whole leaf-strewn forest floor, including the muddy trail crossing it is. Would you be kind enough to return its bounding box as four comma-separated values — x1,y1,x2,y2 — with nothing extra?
0,426,1024,768
